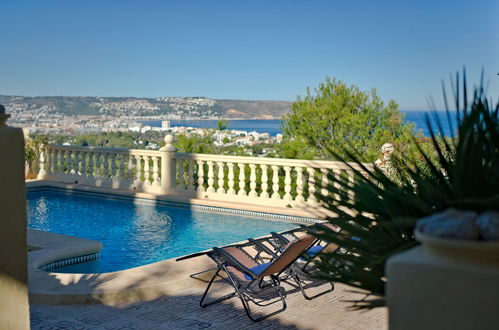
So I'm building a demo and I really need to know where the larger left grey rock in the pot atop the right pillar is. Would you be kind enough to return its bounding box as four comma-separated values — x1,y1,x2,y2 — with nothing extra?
416,208,480,240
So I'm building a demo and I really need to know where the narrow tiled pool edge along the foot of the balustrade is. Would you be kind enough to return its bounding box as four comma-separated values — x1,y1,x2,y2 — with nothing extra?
26,186,321,224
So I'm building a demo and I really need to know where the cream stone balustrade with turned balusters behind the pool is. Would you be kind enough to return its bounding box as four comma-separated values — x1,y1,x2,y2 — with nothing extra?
38,135,372,207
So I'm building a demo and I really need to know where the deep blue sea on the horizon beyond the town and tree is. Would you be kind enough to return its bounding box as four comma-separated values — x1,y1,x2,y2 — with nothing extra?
142,110,457,136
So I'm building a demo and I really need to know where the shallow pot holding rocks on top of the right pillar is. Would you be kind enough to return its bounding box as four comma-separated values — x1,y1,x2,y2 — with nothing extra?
414,230,499,267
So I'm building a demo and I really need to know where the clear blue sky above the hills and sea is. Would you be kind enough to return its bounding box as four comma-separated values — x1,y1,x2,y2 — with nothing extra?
0,0,499,110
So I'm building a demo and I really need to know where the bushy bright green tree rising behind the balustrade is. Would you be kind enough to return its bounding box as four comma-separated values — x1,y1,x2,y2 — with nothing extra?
281,78,414,162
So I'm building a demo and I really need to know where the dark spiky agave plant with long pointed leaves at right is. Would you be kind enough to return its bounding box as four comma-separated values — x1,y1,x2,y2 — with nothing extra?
312,73,499,308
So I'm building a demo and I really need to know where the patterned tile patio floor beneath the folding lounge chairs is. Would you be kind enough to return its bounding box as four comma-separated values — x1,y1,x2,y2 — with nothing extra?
31,278,387,330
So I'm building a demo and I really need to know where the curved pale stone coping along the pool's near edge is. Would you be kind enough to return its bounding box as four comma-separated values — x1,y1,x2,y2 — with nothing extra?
28,229,221,305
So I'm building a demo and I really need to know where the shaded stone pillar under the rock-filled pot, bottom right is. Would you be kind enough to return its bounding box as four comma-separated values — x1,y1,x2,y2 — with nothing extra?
386,248,499,330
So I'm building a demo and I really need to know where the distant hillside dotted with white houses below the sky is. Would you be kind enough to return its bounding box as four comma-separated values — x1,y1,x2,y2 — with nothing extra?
0,95,292,119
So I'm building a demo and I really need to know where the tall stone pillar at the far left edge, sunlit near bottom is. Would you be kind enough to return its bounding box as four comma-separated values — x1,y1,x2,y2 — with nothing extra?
0,105,29,329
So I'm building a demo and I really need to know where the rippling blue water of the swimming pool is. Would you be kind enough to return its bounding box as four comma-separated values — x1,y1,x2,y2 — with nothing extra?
27,190,297,273
